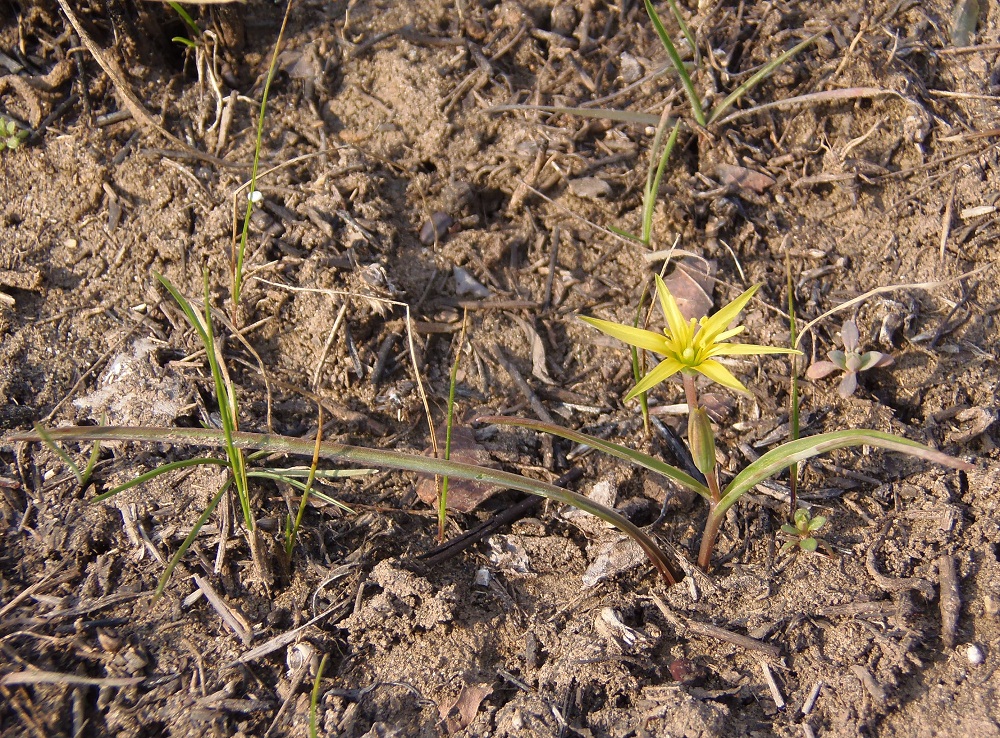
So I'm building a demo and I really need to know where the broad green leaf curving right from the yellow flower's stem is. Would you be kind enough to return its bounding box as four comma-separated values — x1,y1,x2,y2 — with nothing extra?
715,429,975,515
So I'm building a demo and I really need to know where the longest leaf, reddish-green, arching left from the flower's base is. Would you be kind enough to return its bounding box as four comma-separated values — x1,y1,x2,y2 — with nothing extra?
19,426,684,584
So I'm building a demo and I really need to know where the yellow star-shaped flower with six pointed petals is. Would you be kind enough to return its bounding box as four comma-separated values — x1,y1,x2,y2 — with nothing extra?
582,275,802,400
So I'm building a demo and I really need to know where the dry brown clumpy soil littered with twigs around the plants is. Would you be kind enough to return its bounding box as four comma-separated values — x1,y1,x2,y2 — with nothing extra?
0,0,1000,738
